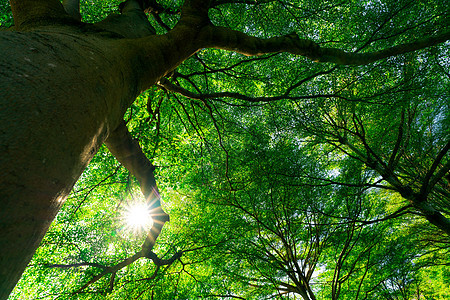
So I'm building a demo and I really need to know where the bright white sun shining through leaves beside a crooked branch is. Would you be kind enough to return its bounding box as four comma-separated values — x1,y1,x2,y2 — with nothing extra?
123,203,153,233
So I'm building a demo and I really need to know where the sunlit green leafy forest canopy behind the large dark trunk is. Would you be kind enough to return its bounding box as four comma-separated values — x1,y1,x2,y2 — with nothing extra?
0,0,450,300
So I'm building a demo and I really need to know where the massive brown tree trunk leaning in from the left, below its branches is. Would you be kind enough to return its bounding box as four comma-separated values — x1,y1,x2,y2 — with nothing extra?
0,29,139,299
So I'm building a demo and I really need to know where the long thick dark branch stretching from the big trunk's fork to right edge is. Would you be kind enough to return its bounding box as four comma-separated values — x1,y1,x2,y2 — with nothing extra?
202,26,450,65
